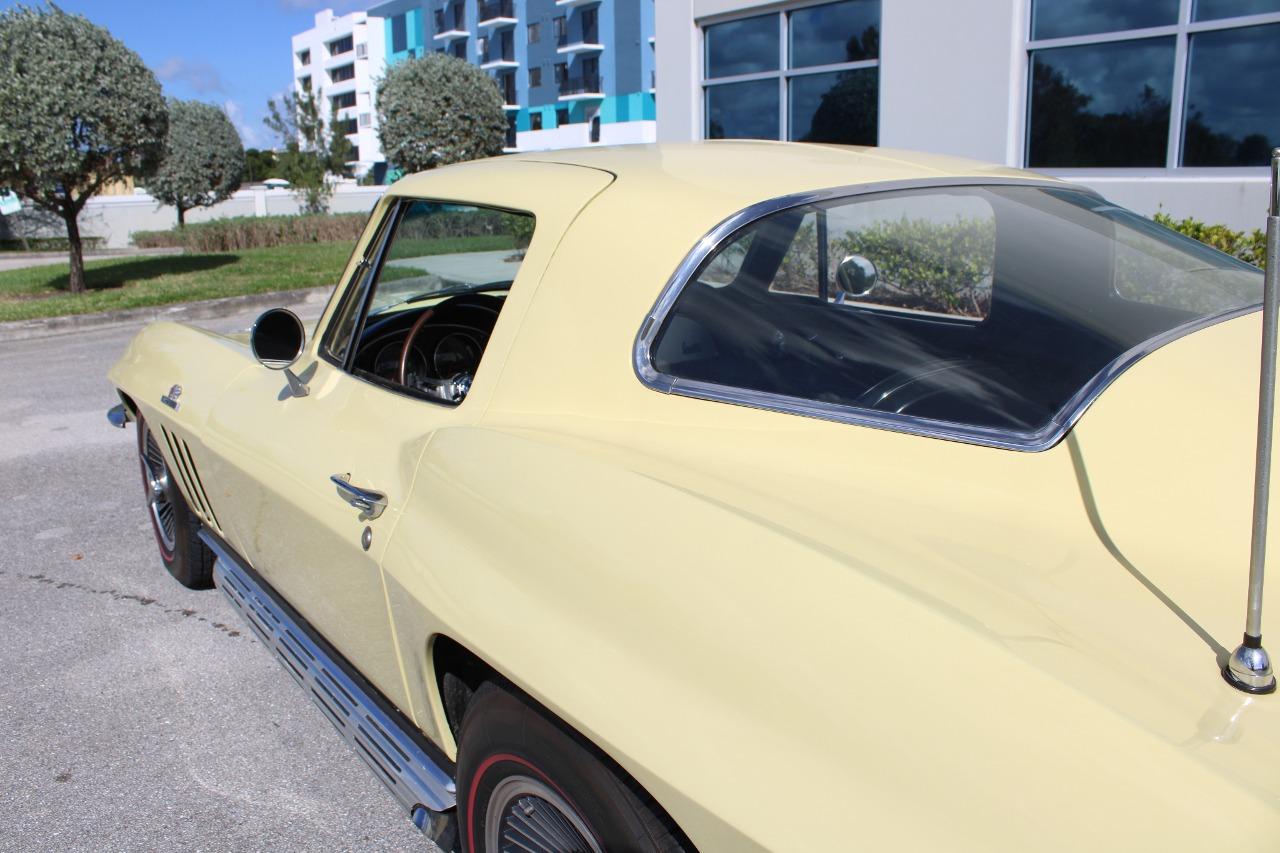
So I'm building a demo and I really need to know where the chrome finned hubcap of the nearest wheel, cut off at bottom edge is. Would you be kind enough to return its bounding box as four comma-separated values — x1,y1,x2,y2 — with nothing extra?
485,776,603,853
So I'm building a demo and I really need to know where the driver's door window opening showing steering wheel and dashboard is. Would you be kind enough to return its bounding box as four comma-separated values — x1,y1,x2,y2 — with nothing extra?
329,199,534,405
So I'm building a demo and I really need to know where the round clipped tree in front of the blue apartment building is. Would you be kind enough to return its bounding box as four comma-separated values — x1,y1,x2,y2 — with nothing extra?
378,54,507,172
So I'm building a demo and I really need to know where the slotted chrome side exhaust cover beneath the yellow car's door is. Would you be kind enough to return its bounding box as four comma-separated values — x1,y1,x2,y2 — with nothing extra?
200,530,457,815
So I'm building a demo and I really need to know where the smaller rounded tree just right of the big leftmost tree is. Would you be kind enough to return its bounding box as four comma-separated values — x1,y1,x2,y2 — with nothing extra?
146,97,244,228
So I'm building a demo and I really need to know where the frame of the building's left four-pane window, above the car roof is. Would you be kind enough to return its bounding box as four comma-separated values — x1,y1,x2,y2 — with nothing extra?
696,0,884,145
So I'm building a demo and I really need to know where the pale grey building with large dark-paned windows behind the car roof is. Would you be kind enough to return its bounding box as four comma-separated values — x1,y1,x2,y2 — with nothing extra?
655,0,1280,229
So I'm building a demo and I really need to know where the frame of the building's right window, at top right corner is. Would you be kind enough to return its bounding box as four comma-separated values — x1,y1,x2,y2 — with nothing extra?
1021,0,1280,174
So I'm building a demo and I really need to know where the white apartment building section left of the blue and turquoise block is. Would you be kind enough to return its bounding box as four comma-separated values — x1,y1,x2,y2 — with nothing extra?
293,9,387,177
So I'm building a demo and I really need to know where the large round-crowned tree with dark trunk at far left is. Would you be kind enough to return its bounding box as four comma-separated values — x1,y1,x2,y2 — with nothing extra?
0,5,169,293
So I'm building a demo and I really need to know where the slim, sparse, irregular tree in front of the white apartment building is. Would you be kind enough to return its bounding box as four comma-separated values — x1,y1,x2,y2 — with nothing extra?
262,91,351,213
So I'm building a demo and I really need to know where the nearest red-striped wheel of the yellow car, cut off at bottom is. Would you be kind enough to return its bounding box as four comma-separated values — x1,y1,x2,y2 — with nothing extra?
458,684,686,853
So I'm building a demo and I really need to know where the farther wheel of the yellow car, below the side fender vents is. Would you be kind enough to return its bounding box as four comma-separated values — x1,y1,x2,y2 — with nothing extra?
138,415,214,589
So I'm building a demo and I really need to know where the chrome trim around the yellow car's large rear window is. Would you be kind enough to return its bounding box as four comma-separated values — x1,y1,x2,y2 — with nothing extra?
632,178,1262,453
